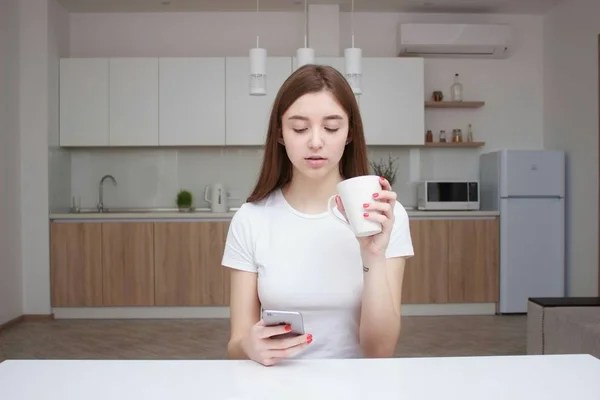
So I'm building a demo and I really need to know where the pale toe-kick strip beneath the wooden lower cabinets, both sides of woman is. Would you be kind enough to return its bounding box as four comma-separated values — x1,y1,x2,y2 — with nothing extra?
53,303,496,319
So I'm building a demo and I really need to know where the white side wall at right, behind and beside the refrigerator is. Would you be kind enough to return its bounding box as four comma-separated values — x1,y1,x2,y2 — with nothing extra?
544,0,600,296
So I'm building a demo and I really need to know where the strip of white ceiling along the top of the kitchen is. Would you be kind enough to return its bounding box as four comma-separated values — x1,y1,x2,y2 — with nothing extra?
57,0,562,14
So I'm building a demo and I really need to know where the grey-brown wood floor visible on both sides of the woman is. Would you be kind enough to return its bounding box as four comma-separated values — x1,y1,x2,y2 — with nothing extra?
0,315,526,362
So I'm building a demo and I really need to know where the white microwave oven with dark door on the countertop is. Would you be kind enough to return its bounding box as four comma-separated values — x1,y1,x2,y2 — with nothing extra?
417,180,479,211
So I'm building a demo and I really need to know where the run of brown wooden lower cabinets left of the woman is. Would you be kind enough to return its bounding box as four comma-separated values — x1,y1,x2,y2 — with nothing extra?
50,221,229,307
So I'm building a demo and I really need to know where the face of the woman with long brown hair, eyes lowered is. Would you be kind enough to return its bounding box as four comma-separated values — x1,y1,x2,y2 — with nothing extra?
281,91,349,179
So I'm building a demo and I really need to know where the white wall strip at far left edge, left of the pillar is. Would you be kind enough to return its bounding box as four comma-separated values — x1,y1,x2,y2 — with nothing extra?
0,0,23,324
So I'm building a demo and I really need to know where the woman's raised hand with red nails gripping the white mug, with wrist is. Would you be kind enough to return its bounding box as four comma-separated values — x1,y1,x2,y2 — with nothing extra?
335,177,397,259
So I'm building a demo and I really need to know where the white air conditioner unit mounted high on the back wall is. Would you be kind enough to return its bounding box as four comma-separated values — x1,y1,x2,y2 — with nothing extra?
397,23,513,58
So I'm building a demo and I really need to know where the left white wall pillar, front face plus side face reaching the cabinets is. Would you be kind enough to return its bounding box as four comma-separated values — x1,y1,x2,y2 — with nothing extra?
19,0,70,314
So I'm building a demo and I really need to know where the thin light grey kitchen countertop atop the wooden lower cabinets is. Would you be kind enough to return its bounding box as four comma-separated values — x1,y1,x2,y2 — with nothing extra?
50,207,500,221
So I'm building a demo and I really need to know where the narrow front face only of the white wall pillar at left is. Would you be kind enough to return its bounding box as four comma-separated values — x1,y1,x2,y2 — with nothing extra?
19,0,50,314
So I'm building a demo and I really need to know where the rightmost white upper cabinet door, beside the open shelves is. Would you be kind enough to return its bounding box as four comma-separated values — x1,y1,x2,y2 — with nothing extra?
359,57,425,145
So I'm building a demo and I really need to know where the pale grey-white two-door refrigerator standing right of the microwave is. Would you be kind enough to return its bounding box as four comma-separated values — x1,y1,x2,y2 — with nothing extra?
479,149,566,314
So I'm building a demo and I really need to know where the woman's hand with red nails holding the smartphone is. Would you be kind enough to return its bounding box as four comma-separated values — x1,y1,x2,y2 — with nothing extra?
241,319,312,366
